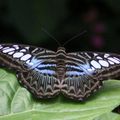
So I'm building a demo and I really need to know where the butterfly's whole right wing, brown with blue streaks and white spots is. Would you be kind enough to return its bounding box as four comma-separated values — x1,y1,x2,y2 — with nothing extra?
62,52,120,100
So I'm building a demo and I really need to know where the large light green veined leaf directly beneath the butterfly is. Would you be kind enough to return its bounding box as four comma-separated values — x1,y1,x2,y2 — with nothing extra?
0,69,120,120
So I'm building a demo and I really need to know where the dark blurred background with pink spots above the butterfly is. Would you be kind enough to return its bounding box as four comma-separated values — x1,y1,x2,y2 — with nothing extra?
0,0,120,53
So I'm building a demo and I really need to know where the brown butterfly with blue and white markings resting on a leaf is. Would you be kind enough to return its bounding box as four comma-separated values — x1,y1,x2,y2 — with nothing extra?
0,44,120,101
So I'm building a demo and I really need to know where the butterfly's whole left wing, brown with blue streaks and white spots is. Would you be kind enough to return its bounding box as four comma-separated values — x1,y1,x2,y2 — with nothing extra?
0,44,60,98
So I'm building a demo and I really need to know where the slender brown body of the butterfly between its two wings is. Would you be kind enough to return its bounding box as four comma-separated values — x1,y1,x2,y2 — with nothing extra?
56,47,66,80
